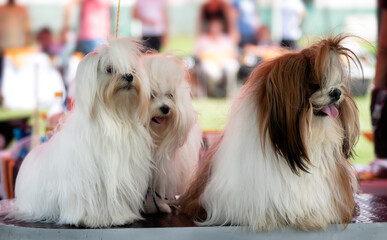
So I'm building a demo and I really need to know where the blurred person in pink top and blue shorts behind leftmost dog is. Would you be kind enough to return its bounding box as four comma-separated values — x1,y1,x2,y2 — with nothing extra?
62,0,110,55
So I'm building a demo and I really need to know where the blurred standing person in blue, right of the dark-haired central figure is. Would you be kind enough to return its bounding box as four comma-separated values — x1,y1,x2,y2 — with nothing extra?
233,0,259,47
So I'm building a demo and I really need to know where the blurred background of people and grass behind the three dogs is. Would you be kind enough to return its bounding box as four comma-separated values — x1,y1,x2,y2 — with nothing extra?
0,0,384,198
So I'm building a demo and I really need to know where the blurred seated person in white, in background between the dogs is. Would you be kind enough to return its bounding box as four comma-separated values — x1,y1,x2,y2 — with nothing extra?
195,18,239,97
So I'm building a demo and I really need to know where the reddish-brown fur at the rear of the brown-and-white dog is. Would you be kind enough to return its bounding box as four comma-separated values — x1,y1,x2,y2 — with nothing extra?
178,134,223,220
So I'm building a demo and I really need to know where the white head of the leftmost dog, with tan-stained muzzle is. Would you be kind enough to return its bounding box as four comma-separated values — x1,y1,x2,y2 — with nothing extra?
76,38,150,122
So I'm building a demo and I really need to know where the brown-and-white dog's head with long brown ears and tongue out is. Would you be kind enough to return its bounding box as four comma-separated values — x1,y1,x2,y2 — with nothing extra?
252,36,359,174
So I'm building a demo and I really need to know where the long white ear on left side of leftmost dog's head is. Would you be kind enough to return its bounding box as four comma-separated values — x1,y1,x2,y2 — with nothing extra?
75,52,99,117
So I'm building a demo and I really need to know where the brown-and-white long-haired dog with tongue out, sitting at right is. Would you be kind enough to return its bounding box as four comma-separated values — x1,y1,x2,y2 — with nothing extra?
180,36,359,230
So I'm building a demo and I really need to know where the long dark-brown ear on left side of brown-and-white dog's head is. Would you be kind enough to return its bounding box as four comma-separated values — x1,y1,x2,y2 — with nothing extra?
258,53,311,174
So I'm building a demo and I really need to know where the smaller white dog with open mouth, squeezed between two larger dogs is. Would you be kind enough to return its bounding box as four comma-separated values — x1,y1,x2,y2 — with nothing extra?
141,54,202,213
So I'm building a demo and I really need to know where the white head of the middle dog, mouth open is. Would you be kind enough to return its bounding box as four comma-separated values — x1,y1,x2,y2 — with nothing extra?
142,55,196,147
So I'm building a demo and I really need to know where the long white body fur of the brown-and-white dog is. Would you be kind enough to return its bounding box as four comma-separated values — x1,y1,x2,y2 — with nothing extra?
200,51,357,230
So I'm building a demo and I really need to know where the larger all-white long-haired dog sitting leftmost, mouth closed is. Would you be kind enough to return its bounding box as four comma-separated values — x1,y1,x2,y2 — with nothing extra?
11,38,152,227
